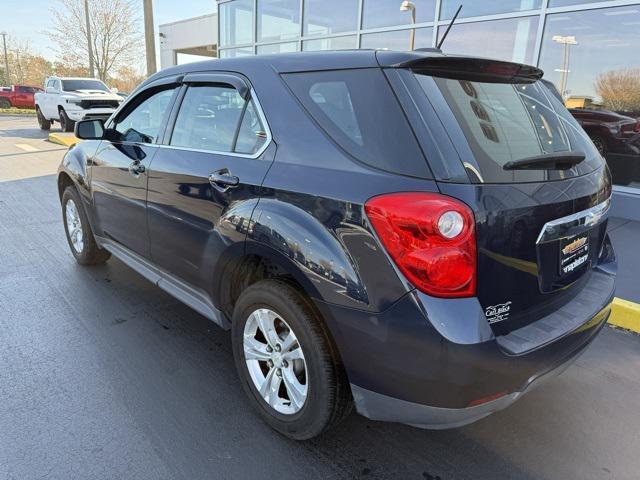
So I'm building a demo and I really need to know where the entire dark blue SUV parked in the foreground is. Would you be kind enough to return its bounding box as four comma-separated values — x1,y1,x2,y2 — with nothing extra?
58,50,616,439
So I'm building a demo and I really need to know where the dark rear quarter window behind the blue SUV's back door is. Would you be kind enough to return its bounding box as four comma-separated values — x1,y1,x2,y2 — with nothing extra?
283,68,431,178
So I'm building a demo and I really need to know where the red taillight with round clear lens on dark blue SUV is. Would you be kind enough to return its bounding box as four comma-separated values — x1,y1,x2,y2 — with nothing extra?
364,192,476,298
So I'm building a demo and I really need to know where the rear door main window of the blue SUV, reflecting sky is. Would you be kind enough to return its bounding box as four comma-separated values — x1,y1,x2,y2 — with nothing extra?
170,85,245,152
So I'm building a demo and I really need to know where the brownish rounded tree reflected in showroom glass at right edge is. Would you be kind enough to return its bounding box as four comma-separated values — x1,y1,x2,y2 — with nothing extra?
595,68,640,112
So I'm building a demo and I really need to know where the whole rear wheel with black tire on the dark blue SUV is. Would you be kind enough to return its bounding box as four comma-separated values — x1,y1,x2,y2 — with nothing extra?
231,279,352,440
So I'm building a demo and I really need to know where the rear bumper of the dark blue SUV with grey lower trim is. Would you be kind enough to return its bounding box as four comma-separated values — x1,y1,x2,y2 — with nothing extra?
318,238,616,428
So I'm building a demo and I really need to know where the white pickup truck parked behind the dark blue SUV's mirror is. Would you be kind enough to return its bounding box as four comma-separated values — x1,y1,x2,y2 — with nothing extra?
35,77,123,132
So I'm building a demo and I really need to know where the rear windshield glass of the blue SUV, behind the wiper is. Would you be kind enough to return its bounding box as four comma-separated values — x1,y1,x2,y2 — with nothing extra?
416,73,602,183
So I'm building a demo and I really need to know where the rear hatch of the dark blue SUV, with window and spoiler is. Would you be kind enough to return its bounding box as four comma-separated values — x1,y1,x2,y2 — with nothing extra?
385,56,611,335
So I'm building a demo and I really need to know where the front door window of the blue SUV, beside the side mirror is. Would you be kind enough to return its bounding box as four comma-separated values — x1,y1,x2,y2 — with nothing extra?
115,88,175,143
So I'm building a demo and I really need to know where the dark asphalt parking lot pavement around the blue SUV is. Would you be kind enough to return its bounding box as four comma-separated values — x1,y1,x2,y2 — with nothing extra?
0,113,640,480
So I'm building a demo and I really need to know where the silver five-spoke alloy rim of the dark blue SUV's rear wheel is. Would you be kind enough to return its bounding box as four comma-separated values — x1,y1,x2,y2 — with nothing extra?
243,308,309,415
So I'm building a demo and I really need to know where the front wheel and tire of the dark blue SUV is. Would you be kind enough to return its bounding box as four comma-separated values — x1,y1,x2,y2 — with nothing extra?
62,186,111,265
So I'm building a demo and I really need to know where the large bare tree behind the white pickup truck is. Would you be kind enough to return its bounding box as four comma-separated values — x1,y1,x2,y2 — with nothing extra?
47,0,144,80
